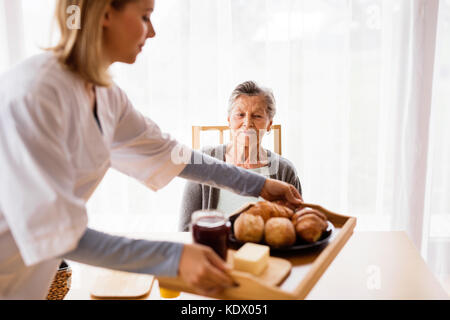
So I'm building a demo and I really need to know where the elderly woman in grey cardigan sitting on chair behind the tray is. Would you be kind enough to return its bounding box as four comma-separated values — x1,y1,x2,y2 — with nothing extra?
179,81,301,231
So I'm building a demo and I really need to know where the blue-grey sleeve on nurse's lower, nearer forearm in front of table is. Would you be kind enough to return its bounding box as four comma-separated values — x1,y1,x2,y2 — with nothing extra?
61,228,183,277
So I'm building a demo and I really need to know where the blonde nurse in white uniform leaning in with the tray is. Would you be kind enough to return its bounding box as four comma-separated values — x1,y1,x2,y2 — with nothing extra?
0,0,302,299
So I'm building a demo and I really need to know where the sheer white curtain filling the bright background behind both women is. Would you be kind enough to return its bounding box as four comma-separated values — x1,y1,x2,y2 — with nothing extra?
0,0,450,288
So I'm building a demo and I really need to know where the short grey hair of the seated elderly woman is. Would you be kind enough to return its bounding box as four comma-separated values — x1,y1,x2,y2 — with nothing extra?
228,81,277,120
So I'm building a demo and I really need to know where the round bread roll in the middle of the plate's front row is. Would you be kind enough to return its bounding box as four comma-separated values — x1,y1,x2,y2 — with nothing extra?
264,217,296,248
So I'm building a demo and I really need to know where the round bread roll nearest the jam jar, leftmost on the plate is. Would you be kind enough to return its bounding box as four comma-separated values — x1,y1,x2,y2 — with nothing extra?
234,213,264,243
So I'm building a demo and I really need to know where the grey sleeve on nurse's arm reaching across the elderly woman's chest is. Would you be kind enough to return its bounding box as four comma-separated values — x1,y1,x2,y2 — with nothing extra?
179,151,266,197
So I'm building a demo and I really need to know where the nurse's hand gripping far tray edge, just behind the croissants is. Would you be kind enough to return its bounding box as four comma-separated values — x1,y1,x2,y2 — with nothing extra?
260,179,303,210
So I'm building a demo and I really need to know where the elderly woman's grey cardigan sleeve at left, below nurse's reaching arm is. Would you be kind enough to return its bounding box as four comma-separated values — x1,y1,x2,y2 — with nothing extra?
178,181,203,231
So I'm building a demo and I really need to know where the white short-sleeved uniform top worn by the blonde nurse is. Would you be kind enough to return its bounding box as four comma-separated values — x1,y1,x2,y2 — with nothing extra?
0,53,185,299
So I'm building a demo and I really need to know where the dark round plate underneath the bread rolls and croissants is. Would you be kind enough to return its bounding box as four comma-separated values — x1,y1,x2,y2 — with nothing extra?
229,213,335,253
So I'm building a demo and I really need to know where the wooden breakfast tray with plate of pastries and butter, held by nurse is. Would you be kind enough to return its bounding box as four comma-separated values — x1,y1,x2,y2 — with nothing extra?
158,201,356,300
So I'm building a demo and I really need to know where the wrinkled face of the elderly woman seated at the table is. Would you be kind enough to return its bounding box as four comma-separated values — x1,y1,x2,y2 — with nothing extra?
228,95,272,146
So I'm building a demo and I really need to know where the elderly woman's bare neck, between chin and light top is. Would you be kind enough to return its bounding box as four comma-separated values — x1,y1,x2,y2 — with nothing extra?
225,143,268,169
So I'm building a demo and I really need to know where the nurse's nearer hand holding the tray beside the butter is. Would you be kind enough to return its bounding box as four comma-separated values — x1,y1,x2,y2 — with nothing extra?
178,244,236,295
